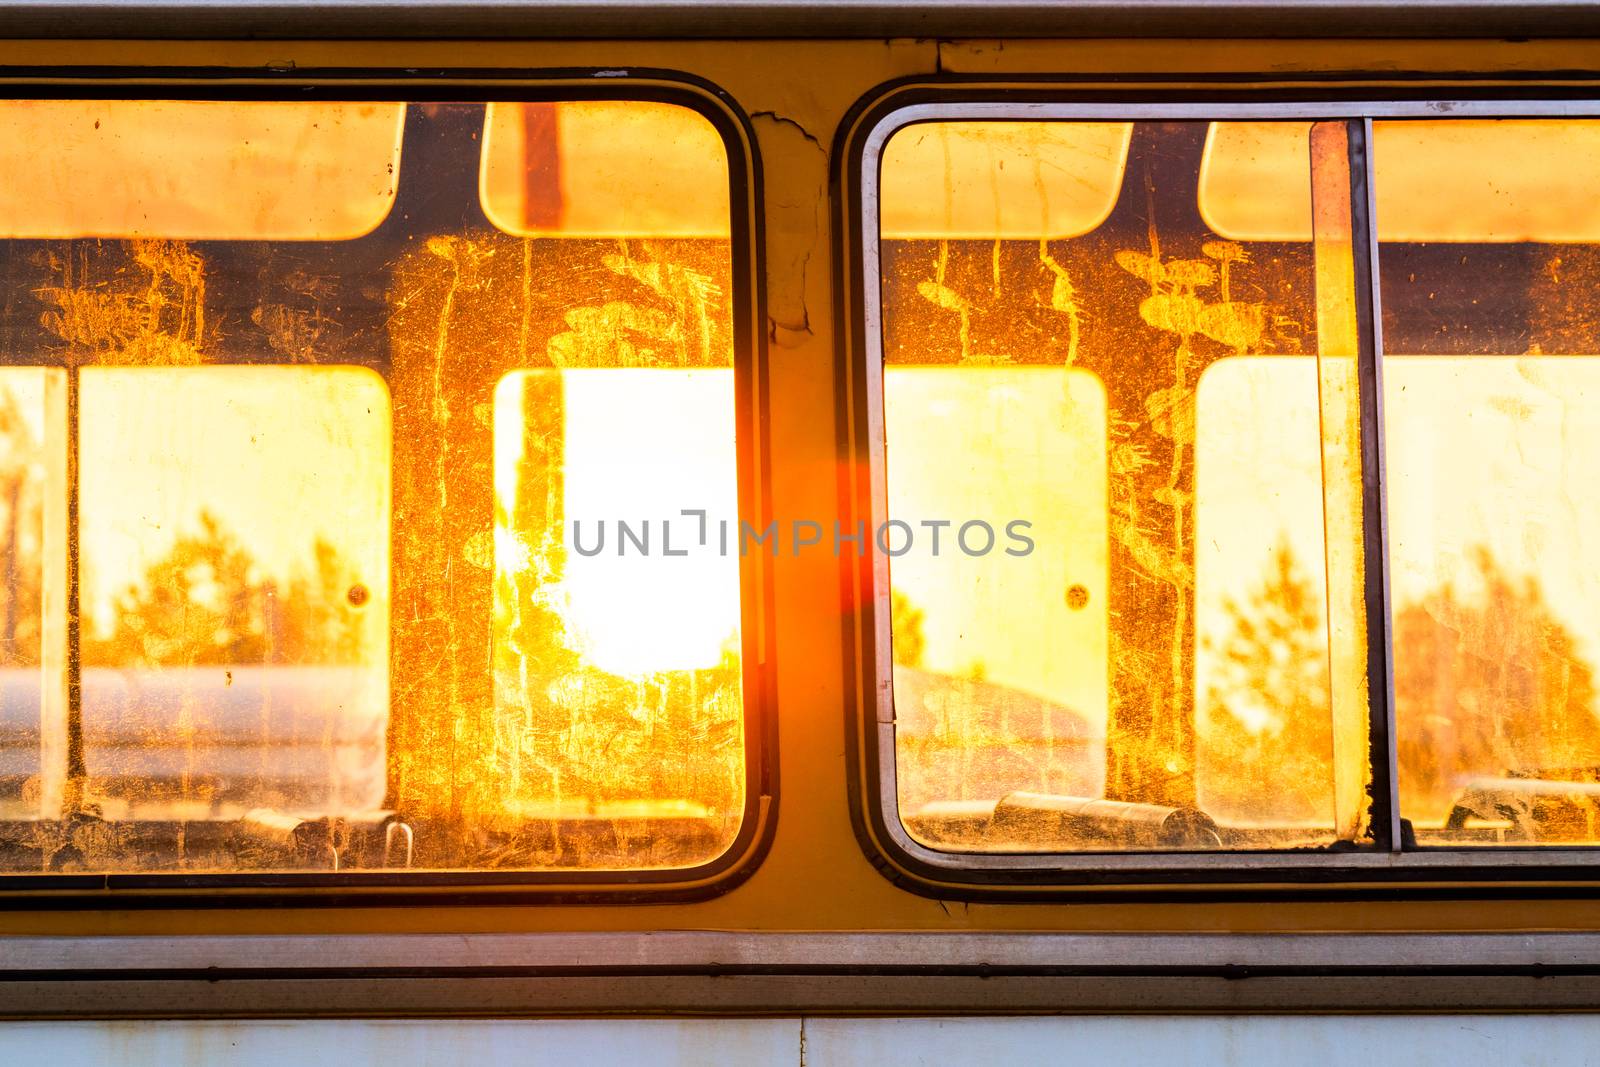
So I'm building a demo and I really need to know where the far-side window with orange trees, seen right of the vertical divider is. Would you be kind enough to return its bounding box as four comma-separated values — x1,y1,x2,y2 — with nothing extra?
1386,357,1600,843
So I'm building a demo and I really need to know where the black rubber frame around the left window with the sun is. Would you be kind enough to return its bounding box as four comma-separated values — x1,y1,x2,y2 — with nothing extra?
0,67,778,910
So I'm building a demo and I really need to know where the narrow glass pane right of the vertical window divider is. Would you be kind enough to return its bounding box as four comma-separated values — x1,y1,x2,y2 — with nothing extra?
1374,120,1600,845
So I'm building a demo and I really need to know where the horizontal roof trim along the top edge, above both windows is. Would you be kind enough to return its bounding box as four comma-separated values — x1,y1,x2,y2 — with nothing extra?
0,0,1600,40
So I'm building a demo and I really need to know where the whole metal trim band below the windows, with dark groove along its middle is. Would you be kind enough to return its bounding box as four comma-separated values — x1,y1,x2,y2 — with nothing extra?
15,931,1600,1019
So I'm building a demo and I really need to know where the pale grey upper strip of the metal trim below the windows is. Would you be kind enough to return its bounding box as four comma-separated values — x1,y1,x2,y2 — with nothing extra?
15,929,1600,979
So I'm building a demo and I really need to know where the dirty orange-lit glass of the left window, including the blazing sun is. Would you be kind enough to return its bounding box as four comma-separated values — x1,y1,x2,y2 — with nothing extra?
0,101,746,873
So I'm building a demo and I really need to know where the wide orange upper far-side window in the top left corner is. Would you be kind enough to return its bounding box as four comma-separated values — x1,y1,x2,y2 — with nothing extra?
0,101,405,240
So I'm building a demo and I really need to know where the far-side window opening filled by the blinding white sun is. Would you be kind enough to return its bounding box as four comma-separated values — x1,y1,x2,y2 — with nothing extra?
494,368,744,865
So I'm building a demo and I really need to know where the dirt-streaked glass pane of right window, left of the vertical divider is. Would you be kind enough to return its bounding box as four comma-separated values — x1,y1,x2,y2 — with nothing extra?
877,122,1349,853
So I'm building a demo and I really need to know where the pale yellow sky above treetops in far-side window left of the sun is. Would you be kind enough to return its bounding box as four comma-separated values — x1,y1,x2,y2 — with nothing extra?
78,366,389,643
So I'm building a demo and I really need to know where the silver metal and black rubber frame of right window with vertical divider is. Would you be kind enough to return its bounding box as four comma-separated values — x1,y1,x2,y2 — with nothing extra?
834,83,1600,901
